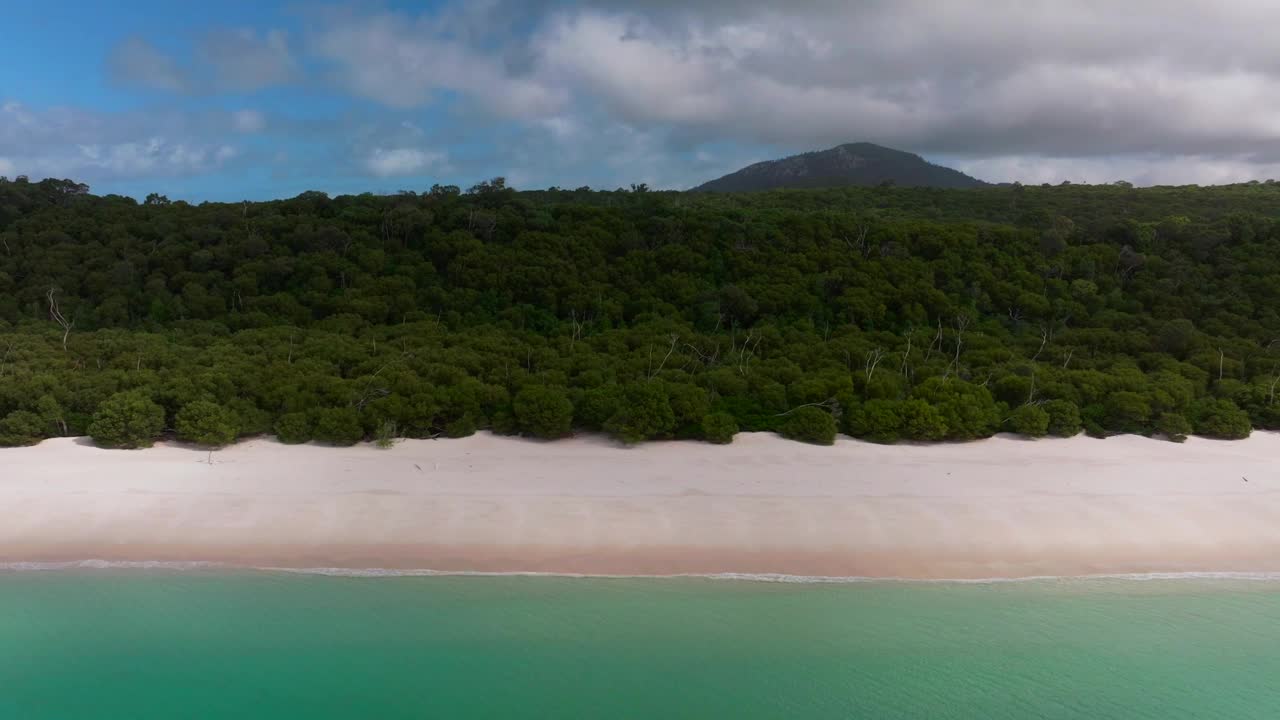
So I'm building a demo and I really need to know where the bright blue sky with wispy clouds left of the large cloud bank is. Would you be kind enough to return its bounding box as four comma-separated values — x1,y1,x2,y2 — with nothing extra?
0,1,769,200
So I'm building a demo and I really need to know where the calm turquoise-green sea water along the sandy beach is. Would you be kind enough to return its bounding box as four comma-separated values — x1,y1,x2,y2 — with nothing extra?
0,570,1280,720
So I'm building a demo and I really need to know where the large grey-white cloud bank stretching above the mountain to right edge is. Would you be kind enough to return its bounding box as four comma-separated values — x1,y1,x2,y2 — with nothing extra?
282,0,1280,179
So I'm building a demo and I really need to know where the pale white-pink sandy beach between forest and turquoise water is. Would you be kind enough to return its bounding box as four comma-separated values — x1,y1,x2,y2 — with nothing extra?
0,433,1280,578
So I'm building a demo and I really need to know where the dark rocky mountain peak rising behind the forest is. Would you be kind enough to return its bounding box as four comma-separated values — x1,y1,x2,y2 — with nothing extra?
694,142,987,192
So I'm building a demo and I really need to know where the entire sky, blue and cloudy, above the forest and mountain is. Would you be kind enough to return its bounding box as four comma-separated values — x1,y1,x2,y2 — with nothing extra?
0,0,1280,201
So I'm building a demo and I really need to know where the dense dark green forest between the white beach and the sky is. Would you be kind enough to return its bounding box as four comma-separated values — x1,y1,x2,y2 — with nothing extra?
0,172,1280,447
